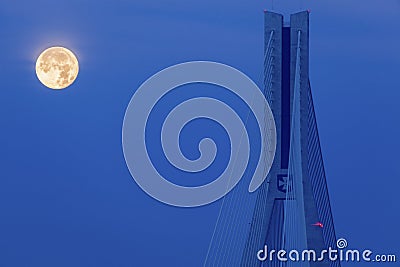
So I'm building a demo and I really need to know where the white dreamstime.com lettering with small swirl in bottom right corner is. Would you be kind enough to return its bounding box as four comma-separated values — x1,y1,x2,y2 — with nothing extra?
257,238,396,262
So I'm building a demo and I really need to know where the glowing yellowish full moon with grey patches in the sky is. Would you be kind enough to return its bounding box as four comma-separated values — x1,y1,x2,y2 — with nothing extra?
36,46,79,89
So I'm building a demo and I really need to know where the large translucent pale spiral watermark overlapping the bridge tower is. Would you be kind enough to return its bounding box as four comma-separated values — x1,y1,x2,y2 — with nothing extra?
122,61,276,207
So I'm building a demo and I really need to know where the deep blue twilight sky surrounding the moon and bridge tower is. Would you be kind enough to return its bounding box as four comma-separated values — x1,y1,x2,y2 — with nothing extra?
0,0,400,267
